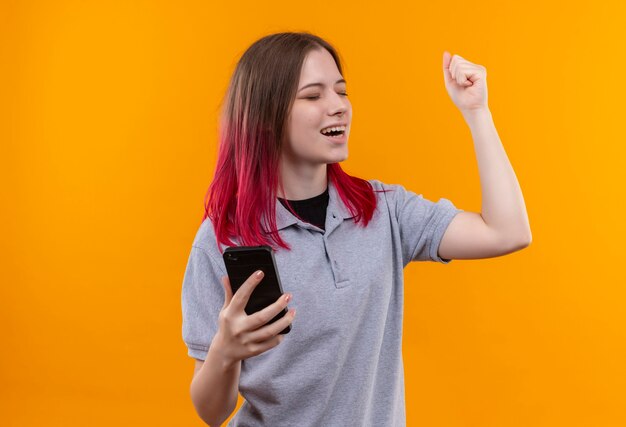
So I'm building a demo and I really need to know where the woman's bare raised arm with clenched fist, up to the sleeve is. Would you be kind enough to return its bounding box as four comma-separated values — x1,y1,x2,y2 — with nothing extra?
439,52,532,259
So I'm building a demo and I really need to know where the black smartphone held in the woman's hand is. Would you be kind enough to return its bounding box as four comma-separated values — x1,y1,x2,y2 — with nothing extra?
223,245,291,334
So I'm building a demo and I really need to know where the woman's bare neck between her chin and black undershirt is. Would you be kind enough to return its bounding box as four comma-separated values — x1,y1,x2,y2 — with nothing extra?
278,158,328,200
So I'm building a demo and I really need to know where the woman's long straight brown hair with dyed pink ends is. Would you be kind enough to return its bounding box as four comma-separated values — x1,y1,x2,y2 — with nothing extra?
202,33,376,252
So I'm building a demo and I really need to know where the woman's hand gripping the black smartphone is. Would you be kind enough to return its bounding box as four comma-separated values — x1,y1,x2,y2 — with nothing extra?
211,273,296,365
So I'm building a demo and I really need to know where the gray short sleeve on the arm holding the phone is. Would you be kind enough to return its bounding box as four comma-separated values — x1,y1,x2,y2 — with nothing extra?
182,246,225,360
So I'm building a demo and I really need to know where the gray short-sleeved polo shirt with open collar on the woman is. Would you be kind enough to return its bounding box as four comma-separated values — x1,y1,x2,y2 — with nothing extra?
182,180,462,427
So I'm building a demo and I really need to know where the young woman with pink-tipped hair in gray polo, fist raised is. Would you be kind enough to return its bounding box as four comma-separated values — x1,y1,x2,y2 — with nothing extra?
182,33,530,427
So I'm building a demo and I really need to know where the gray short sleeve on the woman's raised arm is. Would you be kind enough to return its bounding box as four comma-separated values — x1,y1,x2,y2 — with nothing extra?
383,185,463,266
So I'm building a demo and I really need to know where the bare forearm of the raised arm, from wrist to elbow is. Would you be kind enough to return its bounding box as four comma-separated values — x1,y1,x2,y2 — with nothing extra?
462,108,532,243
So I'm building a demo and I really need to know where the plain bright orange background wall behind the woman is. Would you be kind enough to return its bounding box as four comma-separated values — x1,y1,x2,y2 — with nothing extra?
0,0,626,427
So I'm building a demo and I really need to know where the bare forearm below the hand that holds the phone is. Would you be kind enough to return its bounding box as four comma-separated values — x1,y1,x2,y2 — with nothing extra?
191,343,241,426
